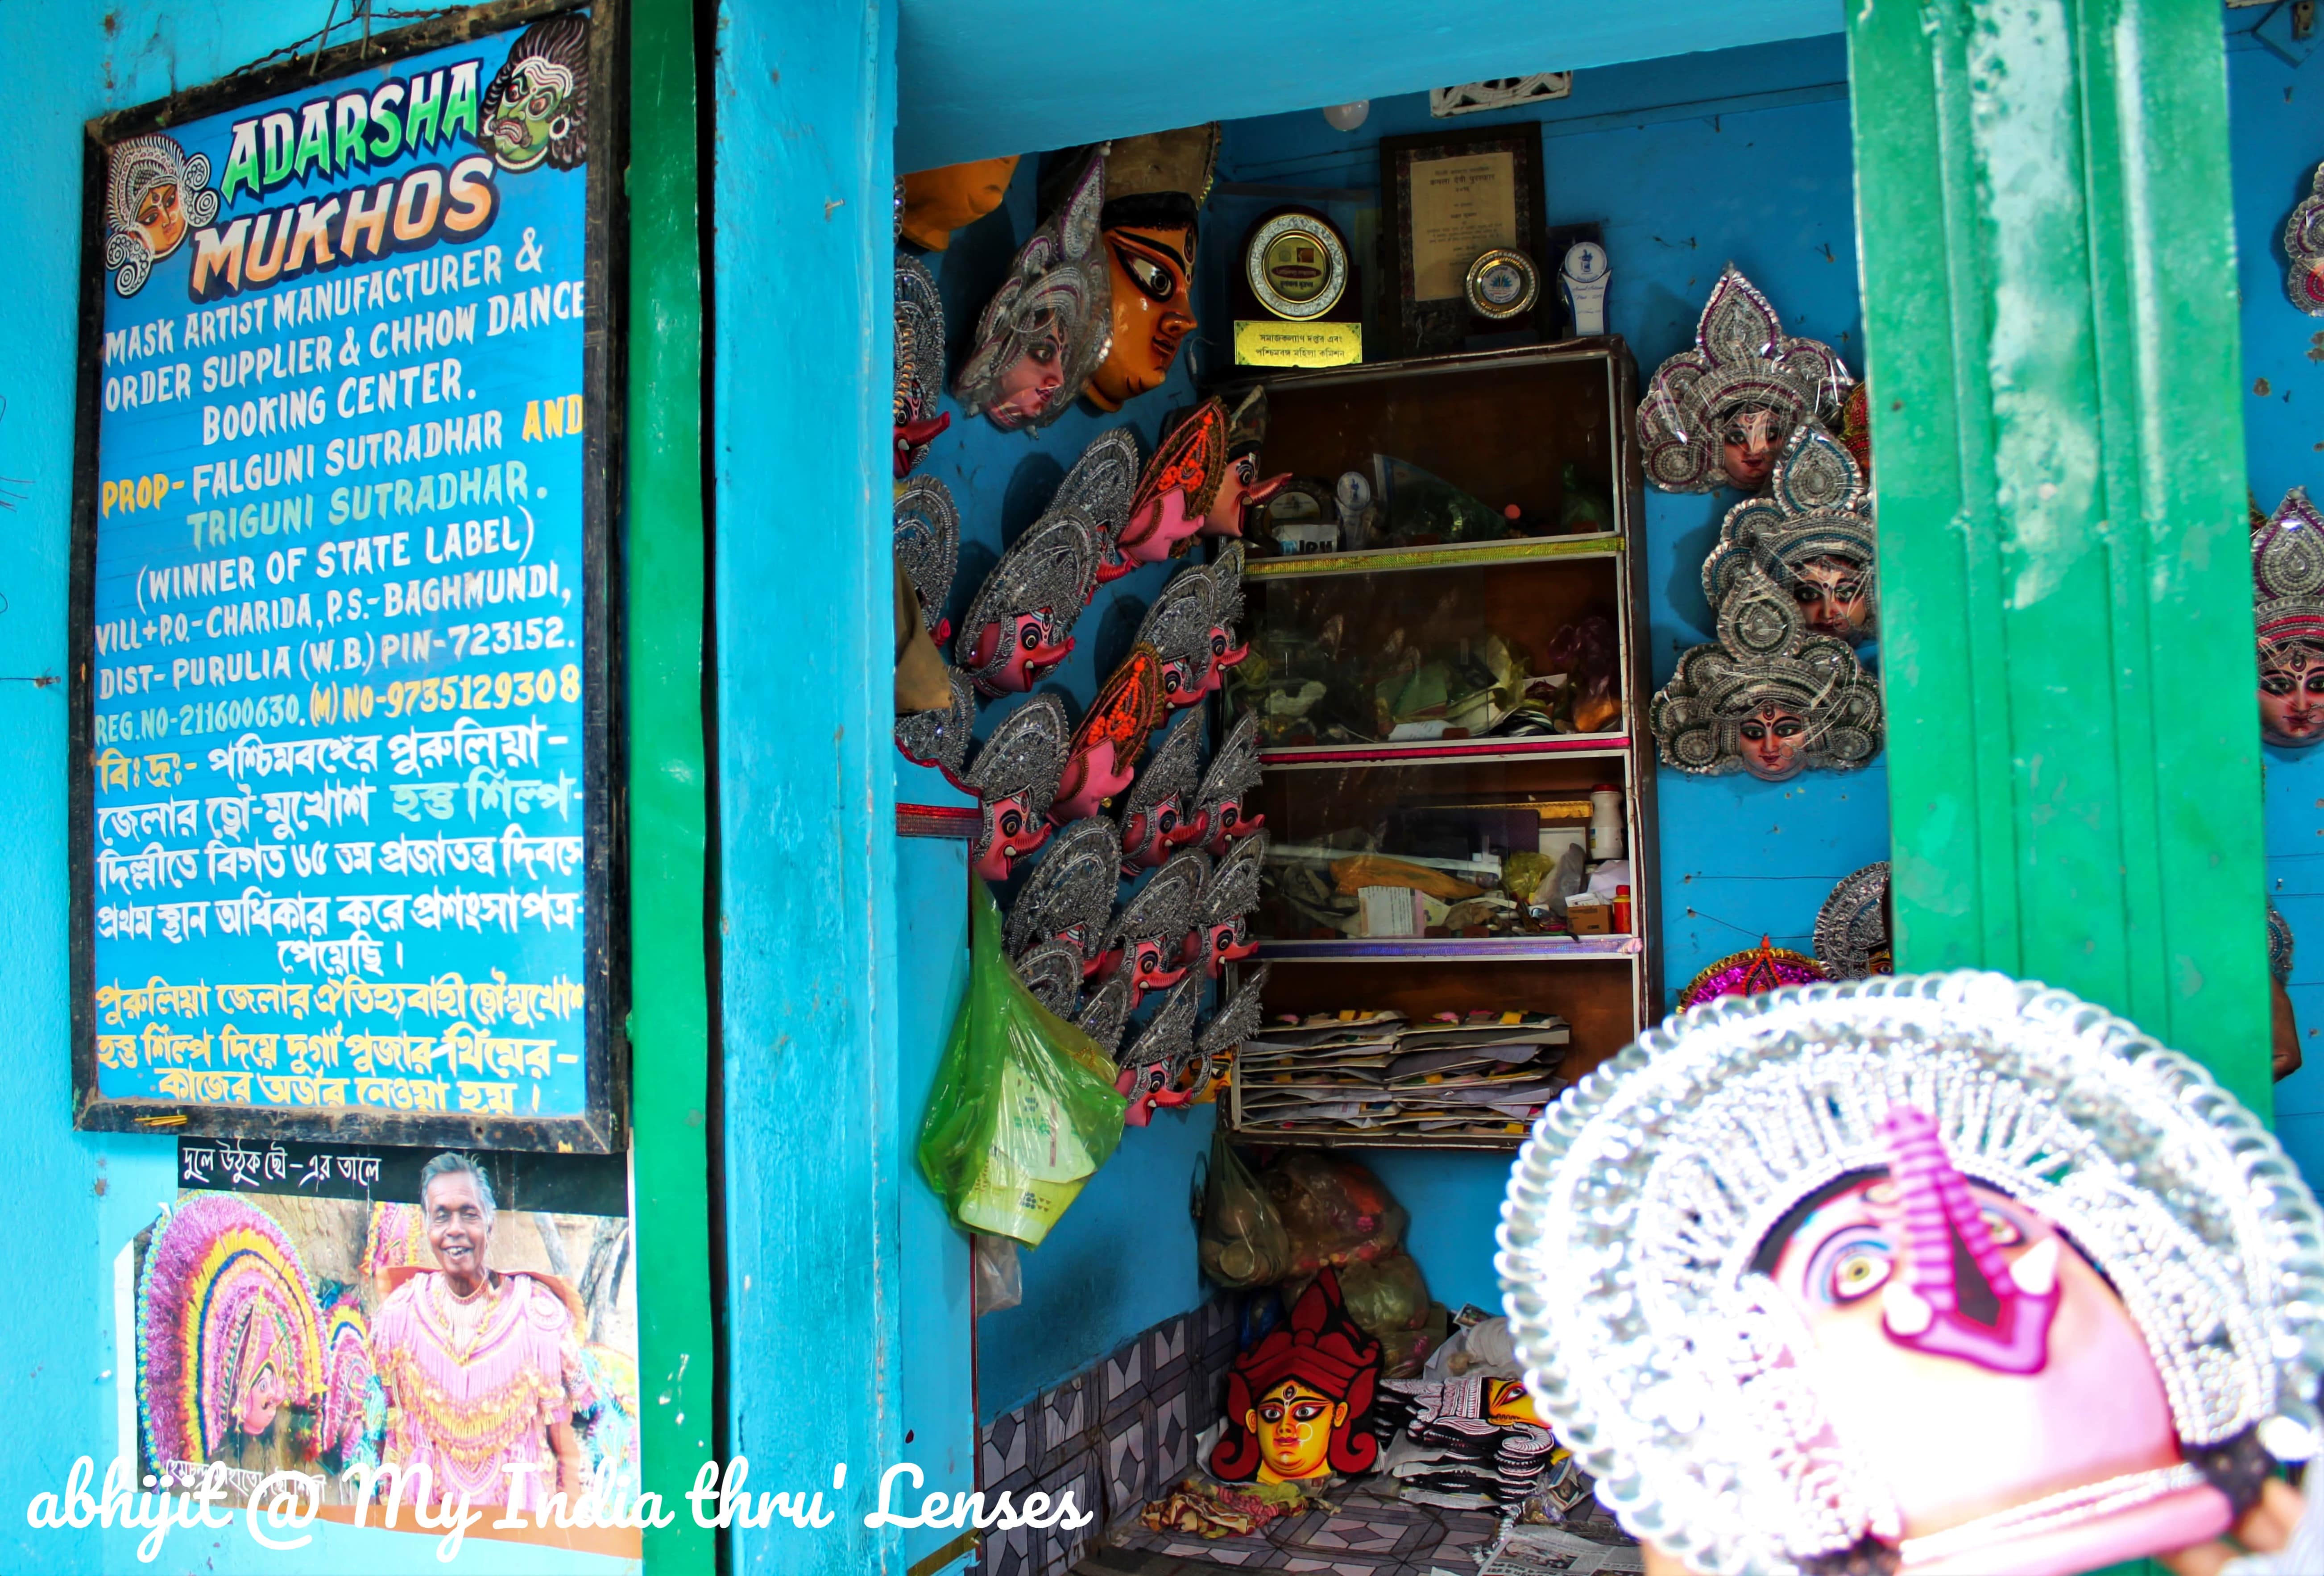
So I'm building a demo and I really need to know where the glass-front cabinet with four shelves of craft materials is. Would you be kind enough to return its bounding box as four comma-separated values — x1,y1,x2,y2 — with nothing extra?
1220,339,1659,1146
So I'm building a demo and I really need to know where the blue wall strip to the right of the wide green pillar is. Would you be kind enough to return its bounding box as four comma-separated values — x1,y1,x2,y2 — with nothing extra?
2226,12,2324,1183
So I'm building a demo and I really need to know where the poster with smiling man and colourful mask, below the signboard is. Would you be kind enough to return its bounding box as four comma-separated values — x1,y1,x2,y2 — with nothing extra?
123,1139,639,1555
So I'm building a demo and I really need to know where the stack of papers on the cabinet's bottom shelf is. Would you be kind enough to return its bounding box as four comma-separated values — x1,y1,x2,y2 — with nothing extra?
1234,1011,1571,1137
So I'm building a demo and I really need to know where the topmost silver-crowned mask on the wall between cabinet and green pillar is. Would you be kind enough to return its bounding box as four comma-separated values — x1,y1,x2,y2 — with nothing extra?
1638,263,1855,493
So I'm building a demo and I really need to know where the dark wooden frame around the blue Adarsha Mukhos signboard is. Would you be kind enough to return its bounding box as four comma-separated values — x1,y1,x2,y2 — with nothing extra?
67,0,630,1153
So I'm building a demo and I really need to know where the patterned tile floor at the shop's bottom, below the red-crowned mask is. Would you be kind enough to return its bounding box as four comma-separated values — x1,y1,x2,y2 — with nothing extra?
1074,1488,1632,1576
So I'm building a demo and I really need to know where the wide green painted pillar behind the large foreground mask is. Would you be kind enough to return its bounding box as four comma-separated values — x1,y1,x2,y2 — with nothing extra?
1845,0,2268,1111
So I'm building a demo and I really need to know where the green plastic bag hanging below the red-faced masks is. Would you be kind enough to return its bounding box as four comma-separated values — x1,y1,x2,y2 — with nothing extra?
920,881,1130,1248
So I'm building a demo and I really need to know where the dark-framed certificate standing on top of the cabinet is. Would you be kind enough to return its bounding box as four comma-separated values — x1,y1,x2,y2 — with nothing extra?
1380,121,1557,358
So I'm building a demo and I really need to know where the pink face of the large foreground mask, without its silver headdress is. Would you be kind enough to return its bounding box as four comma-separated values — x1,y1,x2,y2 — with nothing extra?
1761,1106,2233,1576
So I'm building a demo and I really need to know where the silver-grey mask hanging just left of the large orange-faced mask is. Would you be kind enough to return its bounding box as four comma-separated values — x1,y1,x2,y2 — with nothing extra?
953,153,1113,432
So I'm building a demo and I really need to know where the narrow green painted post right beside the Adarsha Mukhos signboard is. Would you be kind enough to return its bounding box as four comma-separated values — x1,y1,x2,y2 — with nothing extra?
623,0,718,1576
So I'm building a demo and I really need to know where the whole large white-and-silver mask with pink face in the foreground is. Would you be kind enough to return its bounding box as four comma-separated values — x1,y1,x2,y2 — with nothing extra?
1497,972,2324,1576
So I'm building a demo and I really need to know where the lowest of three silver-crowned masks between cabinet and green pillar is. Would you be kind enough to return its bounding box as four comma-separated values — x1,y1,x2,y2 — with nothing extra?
1648,563,1882,783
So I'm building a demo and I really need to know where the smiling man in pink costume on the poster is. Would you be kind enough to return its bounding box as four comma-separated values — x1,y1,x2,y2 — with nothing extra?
372,1153,595,1513
